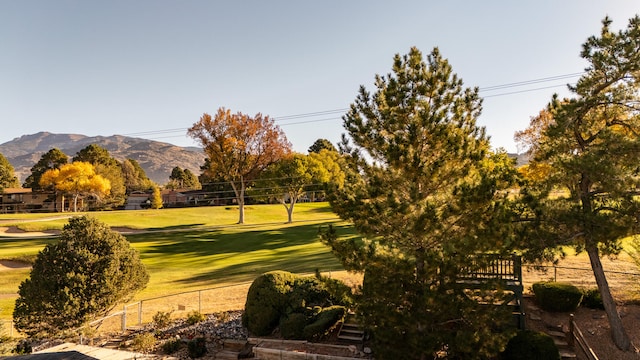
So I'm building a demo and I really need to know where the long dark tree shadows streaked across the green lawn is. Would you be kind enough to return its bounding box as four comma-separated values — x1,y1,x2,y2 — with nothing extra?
130,224,360,286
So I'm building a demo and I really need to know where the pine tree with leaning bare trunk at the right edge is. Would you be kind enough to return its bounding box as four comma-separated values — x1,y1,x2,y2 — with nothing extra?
517,16,640,350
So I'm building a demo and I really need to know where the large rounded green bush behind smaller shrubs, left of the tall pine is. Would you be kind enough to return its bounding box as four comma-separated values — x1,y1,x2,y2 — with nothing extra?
242,271,352,336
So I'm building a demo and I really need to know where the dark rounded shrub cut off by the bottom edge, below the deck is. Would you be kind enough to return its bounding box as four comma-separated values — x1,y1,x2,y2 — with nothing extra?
501,330,560,360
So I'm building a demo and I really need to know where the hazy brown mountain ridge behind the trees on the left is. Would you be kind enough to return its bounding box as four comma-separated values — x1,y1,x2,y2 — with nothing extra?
0,132,205,185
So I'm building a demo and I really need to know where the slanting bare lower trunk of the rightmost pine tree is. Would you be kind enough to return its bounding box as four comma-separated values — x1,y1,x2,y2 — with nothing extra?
586,245,631,351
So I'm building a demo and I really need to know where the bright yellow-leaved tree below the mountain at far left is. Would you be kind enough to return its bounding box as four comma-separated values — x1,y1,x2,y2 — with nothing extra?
40,161,111,212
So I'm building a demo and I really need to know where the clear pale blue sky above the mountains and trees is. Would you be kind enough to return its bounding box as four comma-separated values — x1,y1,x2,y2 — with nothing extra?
0,0,640,152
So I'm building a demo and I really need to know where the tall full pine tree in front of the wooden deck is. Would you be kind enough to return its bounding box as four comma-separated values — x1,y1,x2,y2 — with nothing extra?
323,48,517,359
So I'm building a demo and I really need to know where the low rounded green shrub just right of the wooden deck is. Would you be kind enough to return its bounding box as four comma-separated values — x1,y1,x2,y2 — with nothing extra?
533,281,582,312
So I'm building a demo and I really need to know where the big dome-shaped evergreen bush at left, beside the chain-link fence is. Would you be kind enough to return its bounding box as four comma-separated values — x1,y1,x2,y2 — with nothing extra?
13,216,149,337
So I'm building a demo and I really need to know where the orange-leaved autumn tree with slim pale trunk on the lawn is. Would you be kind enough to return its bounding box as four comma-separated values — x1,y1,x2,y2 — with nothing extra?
187,108,291,224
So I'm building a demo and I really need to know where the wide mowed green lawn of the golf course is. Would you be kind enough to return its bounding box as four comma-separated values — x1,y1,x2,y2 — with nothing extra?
0,203,356,320
